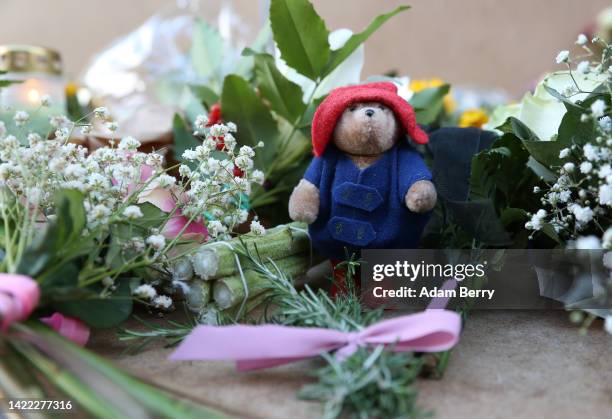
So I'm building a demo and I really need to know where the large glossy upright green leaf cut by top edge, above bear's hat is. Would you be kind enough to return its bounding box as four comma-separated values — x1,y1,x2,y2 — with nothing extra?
270,0,330,80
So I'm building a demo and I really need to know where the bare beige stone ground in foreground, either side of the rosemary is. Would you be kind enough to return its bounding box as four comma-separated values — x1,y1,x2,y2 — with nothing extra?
90,311,612,419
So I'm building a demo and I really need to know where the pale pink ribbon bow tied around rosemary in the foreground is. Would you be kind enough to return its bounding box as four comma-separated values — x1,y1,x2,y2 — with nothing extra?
170,310,461,371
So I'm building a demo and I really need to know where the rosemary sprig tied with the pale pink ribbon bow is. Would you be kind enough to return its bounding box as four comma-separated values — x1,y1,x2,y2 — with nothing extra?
236,246,426,419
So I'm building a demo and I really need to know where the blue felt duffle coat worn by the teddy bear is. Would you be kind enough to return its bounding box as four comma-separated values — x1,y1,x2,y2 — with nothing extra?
304,143,431,259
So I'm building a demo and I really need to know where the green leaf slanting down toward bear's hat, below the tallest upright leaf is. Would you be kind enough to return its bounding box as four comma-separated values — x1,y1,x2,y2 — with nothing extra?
254,54,306,122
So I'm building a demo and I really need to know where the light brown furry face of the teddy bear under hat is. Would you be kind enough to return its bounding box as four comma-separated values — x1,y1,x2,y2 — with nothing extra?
333,102,400,156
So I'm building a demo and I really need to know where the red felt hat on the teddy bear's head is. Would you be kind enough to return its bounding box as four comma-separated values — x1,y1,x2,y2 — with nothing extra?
312,82,429,157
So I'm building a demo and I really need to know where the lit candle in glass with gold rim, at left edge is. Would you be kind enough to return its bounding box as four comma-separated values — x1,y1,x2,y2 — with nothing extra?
0,45,66,134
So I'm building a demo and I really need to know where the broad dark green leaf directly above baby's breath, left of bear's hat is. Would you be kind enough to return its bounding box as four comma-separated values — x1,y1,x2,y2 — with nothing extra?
221,74,278,171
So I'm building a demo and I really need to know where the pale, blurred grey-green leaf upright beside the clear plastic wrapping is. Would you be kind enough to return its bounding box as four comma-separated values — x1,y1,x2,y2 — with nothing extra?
191,18,224,78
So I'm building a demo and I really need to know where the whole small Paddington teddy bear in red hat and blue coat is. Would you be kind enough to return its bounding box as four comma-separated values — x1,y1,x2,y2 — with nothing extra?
289,82,436,292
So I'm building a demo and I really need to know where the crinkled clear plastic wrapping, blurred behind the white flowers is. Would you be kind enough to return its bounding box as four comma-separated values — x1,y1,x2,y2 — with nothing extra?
81,0,260,142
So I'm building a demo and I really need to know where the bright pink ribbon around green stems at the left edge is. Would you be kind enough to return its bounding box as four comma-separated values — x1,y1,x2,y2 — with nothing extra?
0,274,89,346
